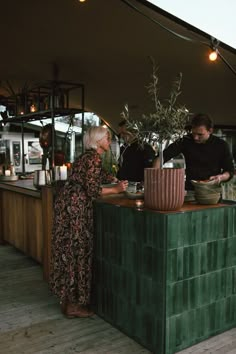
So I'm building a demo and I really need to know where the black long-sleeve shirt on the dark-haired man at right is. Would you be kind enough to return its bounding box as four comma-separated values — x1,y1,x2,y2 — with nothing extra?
163,135,234,190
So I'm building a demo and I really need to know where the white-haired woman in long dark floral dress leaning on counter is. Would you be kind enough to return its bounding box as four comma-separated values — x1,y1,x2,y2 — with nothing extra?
49,127,128,318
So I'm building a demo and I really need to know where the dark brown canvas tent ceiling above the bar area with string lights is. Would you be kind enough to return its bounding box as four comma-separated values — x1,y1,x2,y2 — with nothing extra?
0,0,236,130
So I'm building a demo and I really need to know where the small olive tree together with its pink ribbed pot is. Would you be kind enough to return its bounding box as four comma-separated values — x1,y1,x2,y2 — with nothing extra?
122,59,189,210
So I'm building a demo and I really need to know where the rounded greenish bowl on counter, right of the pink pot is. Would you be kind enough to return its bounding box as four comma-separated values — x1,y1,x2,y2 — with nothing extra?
191,180,221,204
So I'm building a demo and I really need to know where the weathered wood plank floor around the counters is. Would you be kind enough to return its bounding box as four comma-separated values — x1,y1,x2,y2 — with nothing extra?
0,245,236,354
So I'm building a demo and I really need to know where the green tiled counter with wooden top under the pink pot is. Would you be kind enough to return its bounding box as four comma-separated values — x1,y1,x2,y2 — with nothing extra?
94,198,236,354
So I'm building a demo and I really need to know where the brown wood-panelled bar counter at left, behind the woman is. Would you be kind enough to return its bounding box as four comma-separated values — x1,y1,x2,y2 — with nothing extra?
0,181,53,280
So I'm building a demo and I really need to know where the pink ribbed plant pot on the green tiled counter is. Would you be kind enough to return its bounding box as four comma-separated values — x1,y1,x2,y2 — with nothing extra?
144,168,185,211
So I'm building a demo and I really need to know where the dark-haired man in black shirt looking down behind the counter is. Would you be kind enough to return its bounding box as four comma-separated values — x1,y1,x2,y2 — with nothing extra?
154,113,234,190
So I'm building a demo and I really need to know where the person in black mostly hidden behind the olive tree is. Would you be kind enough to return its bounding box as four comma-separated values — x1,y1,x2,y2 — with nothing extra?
117,120,155,182
